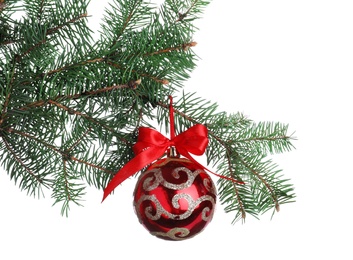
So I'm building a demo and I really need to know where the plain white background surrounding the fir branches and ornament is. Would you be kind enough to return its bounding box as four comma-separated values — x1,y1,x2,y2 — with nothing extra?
0,0,353,260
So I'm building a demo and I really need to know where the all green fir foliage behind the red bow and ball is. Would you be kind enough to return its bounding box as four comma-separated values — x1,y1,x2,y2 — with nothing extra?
0,0,295,221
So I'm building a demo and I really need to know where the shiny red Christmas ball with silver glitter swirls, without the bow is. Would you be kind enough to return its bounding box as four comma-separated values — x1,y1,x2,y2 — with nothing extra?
134,157,217,240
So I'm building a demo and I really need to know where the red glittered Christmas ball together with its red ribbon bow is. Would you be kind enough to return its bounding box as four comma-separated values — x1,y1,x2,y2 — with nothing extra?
103,97,243,240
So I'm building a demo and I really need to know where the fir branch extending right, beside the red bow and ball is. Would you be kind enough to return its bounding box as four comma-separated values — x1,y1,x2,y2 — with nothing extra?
157,96,293,220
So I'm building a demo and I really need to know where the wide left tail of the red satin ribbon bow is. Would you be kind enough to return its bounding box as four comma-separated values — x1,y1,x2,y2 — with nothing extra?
102,147,165,202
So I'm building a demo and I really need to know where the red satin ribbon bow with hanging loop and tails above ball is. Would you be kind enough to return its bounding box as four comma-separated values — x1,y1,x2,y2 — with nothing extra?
102,97,242,202
